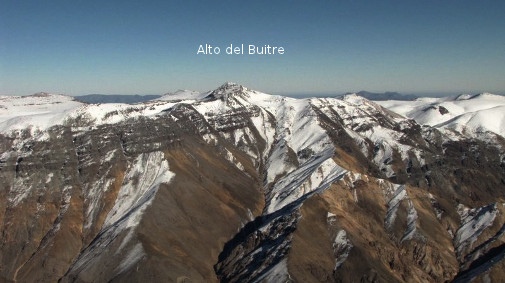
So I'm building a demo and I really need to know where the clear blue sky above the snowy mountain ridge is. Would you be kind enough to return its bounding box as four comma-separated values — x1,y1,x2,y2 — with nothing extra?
0,0,505,95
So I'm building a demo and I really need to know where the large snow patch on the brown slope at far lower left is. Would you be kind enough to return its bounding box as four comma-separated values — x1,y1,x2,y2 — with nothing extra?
71,152,174,278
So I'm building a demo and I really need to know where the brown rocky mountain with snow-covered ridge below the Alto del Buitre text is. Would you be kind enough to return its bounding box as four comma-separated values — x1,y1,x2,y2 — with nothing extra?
0,83,505,282
